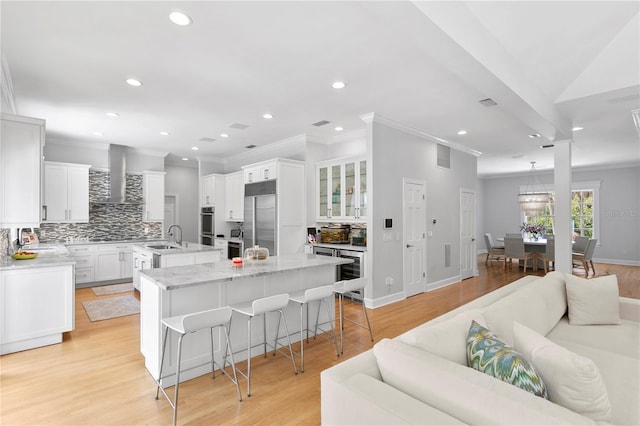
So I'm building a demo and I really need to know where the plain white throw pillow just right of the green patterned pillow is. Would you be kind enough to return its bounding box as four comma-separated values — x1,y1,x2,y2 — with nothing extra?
513,321,612,422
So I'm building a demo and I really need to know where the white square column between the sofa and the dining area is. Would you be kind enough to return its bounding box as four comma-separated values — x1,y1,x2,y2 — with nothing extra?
553,140,572,273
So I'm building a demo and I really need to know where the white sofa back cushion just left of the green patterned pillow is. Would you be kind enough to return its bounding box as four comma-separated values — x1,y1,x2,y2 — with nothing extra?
414,309,487,366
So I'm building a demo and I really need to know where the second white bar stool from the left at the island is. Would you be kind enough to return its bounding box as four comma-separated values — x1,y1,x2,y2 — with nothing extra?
231,293,298,396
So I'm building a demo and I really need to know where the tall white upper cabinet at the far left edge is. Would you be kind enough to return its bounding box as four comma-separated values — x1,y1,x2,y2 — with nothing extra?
0,113,45,228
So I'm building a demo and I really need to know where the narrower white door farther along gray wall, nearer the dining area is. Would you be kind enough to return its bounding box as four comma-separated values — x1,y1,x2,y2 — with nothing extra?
460,189,478,280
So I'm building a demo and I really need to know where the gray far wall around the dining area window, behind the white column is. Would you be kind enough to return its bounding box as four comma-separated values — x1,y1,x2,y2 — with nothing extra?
477,166,640,265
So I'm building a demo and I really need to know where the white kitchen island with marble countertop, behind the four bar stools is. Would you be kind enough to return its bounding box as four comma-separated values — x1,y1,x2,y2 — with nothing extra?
140,254,352,386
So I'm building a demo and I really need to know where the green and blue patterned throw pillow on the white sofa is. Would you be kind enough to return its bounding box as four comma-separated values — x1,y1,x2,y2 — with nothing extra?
467,321,549,399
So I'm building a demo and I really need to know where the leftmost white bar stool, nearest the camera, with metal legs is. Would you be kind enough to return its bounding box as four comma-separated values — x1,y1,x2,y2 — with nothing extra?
156,306,242,426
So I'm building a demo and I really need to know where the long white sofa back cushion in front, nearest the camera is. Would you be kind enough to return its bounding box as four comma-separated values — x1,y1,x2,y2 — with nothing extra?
373,339,595,425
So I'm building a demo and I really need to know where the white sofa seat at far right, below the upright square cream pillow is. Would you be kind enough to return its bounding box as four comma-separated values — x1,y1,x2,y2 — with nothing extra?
546,318,640,425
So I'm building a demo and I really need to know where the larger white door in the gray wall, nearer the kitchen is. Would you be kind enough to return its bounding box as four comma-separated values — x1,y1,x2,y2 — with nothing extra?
402,179,427,297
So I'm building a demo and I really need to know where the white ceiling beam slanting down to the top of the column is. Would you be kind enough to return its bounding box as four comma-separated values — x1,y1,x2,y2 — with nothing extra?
413,1,572,141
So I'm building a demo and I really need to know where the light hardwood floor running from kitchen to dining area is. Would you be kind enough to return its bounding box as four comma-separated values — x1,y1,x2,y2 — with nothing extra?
0,255,640,425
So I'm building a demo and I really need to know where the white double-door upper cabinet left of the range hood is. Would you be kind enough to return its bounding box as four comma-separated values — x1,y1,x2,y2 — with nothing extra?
43,161,91,223
